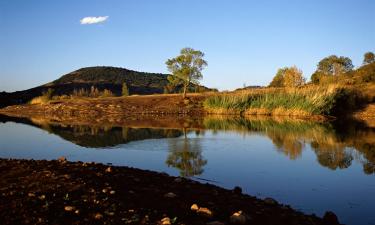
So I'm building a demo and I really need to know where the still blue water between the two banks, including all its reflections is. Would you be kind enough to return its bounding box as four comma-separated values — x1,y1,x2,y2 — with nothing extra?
0,116,375,225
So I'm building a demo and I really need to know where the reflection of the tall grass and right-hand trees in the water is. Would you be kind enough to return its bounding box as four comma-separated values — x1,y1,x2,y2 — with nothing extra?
204,117,375,174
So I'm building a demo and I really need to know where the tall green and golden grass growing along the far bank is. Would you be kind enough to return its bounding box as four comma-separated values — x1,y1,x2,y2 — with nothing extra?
204,86,356,116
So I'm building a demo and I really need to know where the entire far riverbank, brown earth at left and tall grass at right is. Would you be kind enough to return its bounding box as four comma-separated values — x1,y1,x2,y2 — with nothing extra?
0,85,375,121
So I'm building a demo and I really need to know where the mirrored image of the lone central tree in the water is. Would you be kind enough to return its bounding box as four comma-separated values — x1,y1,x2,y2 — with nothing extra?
166,130,207,177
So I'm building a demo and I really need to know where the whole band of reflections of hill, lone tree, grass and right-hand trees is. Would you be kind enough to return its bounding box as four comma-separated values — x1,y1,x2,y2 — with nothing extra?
0,116,375,176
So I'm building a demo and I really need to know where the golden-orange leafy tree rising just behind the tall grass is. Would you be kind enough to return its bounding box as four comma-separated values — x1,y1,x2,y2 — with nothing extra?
269,66,305,87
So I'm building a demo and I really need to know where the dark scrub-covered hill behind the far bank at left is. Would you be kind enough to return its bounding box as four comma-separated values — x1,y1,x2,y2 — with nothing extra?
0,66,216,107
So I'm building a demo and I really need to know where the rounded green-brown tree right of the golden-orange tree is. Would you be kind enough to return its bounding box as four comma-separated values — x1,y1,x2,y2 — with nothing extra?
317,55,354,75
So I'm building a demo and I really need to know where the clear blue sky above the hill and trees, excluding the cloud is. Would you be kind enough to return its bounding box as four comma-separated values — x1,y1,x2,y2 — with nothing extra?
0,0,375,91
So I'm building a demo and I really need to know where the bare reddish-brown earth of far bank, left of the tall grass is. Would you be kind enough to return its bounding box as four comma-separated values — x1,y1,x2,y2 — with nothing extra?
0,94,207,118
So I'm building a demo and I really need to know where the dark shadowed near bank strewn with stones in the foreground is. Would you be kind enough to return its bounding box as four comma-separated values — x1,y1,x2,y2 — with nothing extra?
0,159,337,225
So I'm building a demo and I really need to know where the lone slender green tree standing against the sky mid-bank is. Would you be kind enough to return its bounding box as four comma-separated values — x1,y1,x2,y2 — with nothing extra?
166,48,207,98
